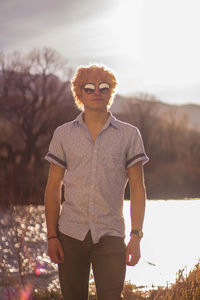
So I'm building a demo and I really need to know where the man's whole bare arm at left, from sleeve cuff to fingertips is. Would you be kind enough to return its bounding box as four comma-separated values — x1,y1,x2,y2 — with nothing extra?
44,164,65,263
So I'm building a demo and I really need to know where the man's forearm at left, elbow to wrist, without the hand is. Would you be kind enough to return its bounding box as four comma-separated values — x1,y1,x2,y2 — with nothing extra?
45,185,61,236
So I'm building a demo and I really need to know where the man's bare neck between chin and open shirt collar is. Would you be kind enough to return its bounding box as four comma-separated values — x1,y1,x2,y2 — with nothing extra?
83,110,109,125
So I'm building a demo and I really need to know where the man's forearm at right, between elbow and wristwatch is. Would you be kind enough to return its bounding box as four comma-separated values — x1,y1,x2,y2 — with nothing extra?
130,186,146,229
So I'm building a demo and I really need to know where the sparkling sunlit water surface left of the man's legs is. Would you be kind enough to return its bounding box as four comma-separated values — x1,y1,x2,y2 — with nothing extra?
0,206,59,299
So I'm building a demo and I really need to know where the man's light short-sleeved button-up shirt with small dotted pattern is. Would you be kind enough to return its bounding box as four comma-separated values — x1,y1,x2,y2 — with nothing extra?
45,112,148,243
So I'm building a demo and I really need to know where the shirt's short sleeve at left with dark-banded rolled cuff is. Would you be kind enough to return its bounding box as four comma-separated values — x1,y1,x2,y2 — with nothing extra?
45,129,67,169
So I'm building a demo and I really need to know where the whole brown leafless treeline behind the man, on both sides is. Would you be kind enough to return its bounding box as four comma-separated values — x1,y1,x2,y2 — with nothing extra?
0,48,200,205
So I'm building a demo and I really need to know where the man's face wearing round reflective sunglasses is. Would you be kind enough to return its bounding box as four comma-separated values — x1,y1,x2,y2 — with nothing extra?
80,70,111,111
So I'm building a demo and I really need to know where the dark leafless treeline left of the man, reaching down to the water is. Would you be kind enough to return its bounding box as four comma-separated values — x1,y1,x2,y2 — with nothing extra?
0,48,78,209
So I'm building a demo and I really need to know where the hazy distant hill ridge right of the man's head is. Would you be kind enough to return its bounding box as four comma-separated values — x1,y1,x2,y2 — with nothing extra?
111,95,200,130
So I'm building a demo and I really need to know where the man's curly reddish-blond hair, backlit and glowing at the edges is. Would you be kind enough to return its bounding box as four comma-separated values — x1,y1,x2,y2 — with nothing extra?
71,64,117,111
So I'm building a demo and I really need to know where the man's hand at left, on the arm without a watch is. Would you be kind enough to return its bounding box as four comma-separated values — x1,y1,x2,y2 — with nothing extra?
48,238,64,263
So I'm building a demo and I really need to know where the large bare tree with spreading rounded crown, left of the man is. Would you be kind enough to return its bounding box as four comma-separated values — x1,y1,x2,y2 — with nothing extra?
0,48,77,167
